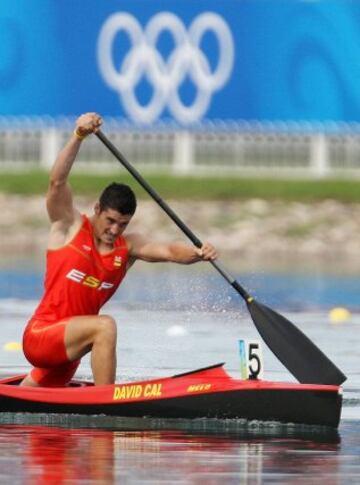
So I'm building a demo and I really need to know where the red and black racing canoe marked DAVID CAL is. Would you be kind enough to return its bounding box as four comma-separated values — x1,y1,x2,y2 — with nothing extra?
0,363,342,428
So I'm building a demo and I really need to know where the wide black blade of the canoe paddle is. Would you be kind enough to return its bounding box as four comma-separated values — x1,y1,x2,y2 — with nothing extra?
247,300,346,385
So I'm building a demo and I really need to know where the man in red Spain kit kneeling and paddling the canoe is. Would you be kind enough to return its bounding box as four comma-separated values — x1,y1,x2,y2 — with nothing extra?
22,113,217,386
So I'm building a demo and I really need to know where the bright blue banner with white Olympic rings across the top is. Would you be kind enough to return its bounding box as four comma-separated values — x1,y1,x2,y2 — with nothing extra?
0,0,360,126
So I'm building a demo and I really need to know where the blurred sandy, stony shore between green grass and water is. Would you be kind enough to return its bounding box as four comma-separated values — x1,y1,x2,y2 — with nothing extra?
0,194,360,269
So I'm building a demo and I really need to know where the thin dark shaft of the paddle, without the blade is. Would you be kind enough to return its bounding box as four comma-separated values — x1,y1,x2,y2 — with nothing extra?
95,130,252,302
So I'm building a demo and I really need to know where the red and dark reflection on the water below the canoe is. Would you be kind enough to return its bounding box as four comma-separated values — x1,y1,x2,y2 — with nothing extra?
0,425,348,484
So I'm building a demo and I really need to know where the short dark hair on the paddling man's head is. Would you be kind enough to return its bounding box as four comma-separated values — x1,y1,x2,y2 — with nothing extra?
99,182,136,215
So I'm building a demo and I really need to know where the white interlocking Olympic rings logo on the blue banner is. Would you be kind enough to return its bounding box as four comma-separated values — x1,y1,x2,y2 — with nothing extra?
97,12,234,123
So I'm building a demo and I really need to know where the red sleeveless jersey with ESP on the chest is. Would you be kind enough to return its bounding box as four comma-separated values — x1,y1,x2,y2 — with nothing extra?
32,215,129,322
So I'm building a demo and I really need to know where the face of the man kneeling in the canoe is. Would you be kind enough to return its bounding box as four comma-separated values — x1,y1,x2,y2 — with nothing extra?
94,204,132,246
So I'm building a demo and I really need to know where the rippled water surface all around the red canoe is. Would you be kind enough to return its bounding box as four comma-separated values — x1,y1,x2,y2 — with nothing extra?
0,266,360,484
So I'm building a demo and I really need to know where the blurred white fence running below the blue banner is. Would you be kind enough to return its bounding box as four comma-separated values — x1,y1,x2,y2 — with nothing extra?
0,118,360,177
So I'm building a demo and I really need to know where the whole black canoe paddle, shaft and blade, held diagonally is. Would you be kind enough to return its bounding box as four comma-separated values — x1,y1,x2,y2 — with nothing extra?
96,130,346,385
